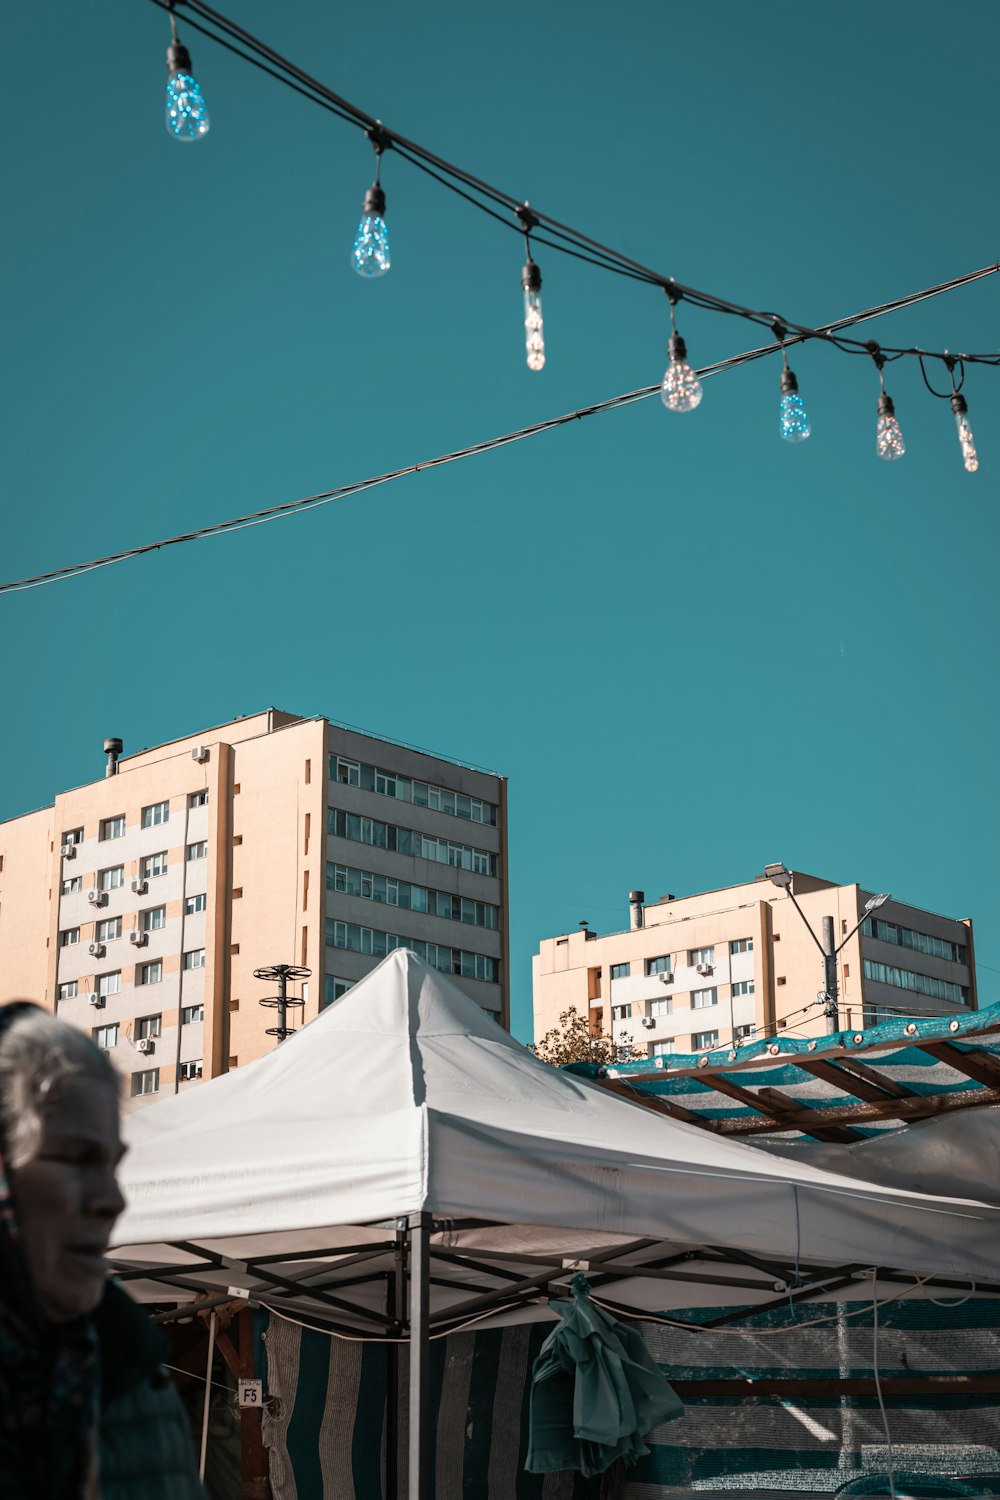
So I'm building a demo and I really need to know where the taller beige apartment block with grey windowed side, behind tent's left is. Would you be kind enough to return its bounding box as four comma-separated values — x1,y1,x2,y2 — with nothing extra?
0,708,510,1101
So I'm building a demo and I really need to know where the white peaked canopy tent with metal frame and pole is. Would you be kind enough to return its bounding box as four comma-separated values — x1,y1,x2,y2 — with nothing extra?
112,951,1000,1500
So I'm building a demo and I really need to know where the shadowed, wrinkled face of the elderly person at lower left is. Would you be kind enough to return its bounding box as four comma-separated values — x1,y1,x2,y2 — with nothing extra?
10,1073,124,1323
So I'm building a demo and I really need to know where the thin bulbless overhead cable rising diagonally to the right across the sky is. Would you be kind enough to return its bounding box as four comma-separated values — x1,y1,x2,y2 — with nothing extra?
0,264,987,594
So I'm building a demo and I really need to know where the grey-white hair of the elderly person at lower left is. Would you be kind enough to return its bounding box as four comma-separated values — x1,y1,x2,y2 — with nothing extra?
0,1005,118,1170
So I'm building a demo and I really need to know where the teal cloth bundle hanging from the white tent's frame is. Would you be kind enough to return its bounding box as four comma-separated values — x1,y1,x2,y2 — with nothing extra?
525,1275,684,1476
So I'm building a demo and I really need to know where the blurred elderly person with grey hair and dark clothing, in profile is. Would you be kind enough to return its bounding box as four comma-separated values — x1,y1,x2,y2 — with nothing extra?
0,1001,204,1500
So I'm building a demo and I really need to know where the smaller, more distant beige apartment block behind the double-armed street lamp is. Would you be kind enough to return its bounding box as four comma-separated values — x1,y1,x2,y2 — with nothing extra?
532,866,978,1058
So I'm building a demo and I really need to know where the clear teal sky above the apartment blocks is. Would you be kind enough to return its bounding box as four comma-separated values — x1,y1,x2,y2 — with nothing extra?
0,0,1000,1037
